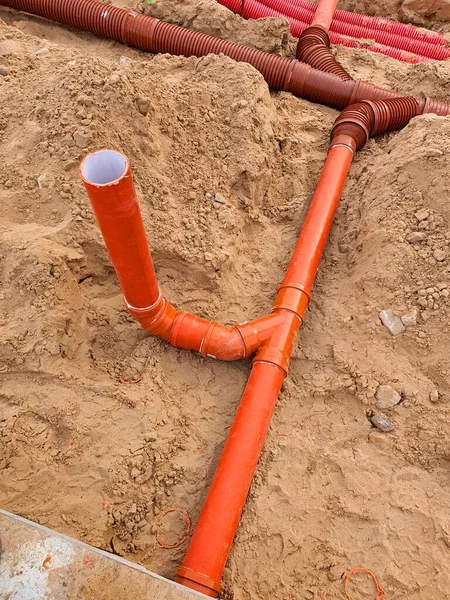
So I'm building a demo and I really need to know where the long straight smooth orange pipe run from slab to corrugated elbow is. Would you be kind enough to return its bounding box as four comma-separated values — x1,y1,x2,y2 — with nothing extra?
177,145,353,598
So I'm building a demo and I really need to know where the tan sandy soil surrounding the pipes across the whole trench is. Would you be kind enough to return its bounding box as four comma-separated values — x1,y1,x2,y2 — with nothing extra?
0,0,450,600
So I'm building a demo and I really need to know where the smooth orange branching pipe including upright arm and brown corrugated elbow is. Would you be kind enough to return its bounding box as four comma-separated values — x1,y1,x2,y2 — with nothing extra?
80,97,424,598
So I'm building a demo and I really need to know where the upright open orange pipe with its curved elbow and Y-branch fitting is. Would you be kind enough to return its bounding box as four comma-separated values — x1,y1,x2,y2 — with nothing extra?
80,150,309,374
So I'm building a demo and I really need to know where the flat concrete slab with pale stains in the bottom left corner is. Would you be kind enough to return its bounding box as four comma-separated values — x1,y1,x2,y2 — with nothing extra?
0,510,202,600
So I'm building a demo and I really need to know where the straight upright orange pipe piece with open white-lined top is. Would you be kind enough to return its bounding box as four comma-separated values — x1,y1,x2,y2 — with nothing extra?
80,150,160,308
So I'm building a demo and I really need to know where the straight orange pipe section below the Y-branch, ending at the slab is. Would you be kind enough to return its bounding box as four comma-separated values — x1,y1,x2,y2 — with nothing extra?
176,362,285,598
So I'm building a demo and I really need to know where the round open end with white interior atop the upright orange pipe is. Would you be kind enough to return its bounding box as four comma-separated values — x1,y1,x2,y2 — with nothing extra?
80,149,130,187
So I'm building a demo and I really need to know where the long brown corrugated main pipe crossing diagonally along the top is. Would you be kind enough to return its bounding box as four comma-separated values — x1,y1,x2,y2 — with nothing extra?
0,0,450,115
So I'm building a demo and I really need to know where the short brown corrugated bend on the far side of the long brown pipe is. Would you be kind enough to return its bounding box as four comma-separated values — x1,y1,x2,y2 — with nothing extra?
296,25,353,81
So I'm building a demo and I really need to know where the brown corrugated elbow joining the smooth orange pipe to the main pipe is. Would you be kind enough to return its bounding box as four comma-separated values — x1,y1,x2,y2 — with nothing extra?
331,96,424,151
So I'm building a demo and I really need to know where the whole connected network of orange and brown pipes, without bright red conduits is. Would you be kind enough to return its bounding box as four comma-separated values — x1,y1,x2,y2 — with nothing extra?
0,0,450,598
